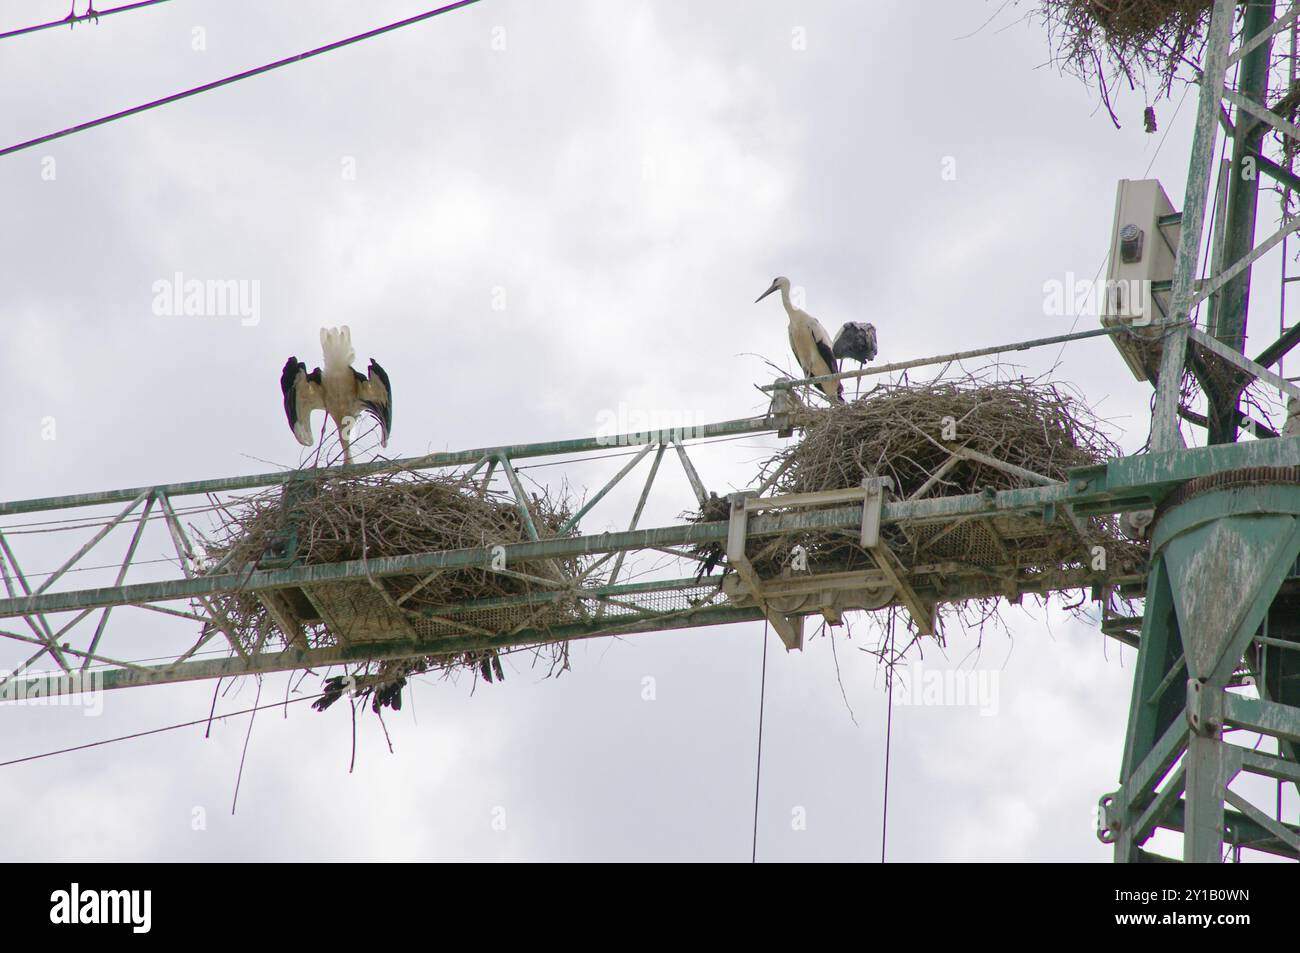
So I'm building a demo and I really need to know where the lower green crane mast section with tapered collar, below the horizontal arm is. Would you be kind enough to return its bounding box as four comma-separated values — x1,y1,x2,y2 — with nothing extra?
1104,475,1300,862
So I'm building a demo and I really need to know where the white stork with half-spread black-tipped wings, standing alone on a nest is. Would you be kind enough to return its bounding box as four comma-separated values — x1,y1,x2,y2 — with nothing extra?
280,325,393,463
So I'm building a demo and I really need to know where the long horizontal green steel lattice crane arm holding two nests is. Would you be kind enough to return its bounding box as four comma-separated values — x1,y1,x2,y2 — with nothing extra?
0,400,1300,686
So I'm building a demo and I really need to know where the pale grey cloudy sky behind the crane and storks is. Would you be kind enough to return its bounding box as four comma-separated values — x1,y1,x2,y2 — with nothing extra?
0,0,1289,861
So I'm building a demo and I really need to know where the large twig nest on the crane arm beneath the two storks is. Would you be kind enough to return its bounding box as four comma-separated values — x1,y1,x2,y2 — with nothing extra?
694,376,1147,602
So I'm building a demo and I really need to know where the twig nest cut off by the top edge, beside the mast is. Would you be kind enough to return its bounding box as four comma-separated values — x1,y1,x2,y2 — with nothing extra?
1036,0,1213,126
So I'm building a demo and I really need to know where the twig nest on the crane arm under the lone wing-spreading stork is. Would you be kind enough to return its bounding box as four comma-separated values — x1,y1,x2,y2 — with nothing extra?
204,471,579,710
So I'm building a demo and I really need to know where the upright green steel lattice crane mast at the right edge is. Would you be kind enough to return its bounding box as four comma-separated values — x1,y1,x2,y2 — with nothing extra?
1099,0,1300,862
